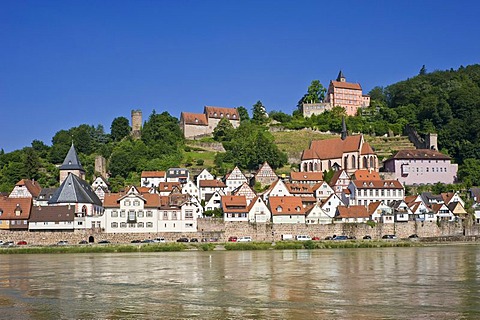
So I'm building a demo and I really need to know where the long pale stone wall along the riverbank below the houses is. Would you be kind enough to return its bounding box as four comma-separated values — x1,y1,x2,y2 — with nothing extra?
0,218,480,245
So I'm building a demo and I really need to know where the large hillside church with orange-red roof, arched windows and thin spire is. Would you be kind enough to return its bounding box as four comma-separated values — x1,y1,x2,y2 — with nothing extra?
300,119,379,174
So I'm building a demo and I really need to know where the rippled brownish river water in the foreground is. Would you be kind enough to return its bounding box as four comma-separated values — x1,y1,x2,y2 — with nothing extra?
0,245,480,319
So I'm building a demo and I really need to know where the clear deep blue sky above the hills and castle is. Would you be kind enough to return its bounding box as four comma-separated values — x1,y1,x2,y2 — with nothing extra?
0,0,480,152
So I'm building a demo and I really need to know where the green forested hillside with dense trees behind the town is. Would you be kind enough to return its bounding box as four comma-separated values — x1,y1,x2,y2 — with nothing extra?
0,65,480,192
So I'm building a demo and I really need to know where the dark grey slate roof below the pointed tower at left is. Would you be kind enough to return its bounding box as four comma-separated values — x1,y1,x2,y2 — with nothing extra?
48,173,102,206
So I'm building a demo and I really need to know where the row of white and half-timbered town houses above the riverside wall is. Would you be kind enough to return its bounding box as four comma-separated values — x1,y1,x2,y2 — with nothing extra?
0,142,480,233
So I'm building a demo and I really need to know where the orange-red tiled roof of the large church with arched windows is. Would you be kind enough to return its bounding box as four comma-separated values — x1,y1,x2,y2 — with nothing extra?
302,135,373,160
